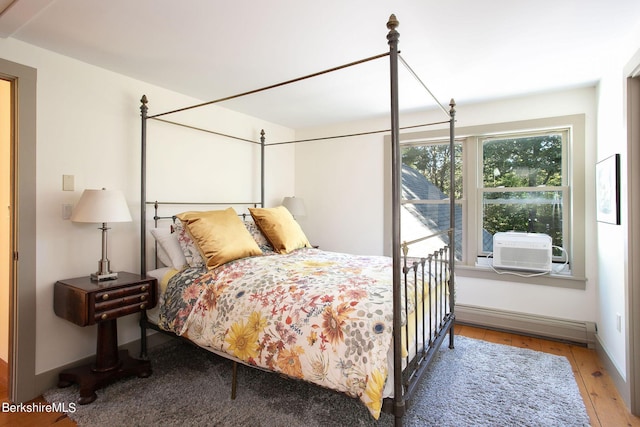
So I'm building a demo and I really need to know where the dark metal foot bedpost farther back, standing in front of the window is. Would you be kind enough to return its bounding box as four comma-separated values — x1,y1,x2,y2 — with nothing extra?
449,98,456,348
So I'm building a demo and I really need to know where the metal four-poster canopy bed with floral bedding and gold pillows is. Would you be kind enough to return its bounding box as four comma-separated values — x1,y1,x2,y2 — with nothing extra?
140,15,455,425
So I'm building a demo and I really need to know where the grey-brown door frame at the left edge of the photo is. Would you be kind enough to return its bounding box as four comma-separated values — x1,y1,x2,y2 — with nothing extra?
0,59,37,402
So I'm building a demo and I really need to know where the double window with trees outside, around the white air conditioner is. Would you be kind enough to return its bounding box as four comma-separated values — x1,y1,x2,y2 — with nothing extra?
390,115,585,289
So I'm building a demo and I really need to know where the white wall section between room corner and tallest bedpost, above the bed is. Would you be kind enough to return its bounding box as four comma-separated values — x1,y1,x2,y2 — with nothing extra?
295,130,384,255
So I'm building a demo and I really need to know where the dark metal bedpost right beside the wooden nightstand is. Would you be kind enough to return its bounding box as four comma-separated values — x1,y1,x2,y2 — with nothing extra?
140,95,148,359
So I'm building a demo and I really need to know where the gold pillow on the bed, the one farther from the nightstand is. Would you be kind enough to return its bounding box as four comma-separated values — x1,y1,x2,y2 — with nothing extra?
249,206,311,254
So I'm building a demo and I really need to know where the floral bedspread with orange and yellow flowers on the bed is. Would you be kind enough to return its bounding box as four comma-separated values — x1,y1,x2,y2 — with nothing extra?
159,248,393,419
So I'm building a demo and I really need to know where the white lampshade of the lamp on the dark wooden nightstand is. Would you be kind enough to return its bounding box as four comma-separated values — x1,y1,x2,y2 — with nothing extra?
71,188,131,223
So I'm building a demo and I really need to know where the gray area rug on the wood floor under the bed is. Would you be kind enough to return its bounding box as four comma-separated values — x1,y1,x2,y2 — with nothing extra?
44,337,589,427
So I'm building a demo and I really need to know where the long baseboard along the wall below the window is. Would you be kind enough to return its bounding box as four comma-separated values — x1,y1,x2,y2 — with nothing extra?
455,304,596,348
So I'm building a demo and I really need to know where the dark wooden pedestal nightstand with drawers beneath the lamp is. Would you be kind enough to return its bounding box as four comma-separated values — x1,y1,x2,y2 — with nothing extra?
53,272,157,405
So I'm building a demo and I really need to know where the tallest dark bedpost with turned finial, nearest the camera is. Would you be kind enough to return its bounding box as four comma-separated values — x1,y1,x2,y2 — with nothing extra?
387,15,405,426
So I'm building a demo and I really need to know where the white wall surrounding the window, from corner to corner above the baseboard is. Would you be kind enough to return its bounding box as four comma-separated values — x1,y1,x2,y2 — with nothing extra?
296,87,598,321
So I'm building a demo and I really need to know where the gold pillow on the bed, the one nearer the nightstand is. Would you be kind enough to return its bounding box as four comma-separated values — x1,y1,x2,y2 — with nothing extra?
176,208,262,269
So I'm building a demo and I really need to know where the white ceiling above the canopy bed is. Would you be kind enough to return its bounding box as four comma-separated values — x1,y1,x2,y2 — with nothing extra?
0,0,640,128
